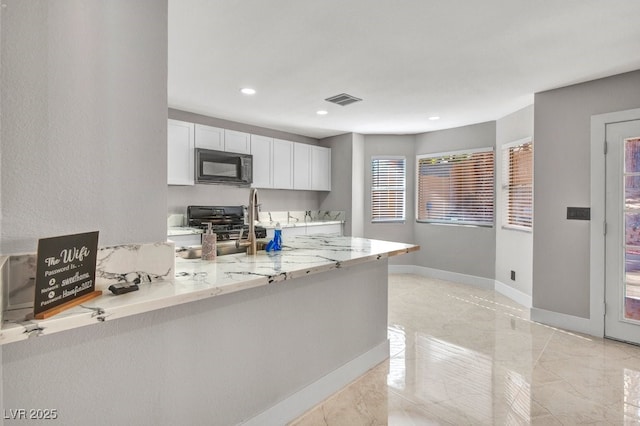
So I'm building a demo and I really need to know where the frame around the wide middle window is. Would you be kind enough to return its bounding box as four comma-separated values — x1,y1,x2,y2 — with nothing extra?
415,146,496,228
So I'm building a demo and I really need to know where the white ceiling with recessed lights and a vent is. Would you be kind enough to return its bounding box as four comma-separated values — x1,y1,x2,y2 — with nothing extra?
168,0,640,138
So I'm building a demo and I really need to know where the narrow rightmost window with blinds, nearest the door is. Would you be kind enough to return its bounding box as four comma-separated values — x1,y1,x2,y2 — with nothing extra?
502,139,533,230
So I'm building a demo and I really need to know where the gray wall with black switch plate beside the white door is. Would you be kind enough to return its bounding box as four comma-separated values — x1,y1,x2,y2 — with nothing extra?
533,71,640,318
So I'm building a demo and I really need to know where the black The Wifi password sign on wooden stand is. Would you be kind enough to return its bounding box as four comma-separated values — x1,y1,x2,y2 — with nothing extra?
33,231,102,319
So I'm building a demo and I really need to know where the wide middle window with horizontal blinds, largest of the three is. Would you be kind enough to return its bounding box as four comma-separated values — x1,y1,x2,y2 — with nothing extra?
417,148,495,226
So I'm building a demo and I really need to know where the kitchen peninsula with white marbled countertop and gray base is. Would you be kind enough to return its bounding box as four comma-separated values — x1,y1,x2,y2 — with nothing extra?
0,235,419,425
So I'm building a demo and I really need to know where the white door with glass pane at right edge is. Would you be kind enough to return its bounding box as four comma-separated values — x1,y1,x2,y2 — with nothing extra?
605,120,640,344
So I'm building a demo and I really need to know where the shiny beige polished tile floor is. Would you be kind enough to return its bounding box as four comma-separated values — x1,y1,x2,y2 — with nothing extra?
291,275,640,426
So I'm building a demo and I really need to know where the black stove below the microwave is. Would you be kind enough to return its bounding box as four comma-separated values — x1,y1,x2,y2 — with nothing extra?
187,206,267,241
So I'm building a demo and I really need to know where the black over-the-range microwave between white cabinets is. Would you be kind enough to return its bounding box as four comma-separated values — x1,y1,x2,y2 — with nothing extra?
196,148,253,186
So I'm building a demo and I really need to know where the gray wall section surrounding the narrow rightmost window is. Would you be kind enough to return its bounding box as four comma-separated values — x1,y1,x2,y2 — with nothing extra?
495,105,535,296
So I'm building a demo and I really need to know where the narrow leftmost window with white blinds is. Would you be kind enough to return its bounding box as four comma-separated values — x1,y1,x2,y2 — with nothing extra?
371,156,407,222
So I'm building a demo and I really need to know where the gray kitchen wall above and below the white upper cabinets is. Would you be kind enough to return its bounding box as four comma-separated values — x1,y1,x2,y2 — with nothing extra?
167,108,322,214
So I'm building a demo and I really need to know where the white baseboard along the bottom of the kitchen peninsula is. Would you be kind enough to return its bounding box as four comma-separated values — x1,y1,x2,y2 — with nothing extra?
242,340,389,426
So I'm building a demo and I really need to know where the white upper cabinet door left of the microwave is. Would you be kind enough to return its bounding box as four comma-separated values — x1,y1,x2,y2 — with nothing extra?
167,120,195,185
